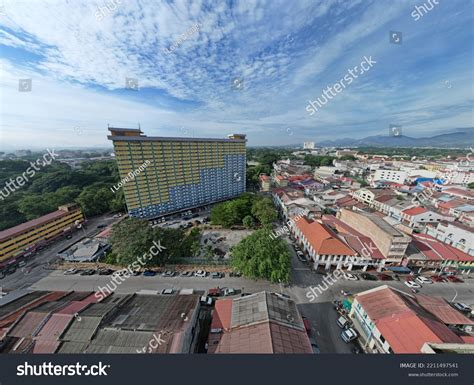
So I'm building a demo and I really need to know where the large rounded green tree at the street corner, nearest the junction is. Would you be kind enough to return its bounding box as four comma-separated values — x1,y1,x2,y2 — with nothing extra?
231,229,291,283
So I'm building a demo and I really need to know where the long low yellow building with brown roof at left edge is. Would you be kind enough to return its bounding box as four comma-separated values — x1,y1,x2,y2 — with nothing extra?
0,204,84,262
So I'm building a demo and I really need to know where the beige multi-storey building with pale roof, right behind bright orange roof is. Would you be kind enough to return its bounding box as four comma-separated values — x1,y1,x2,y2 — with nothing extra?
337,209,411,262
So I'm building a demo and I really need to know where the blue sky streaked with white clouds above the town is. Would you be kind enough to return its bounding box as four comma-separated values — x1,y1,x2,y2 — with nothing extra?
0,0,474,149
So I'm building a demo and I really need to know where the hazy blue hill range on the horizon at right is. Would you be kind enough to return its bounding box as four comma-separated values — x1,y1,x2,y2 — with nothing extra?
317,128,474,148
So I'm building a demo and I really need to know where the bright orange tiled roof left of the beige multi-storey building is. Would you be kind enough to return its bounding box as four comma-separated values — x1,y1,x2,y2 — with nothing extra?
296,217,356,255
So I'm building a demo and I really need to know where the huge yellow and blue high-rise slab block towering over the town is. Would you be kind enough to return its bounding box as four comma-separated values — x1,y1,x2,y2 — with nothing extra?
108,127,246,218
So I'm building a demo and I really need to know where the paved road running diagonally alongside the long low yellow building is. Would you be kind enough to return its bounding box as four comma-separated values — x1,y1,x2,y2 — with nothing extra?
0,215,117,292
